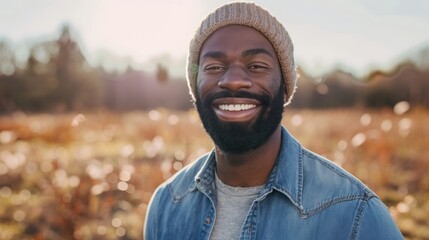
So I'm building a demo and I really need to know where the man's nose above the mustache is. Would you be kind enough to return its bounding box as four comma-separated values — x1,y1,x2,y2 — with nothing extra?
218,66,252,91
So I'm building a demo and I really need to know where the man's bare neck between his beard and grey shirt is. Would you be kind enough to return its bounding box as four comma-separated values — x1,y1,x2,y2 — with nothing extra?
216,124,281,187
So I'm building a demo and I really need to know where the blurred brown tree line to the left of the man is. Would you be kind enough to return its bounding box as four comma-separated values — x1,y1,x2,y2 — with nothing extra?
0,26,192,113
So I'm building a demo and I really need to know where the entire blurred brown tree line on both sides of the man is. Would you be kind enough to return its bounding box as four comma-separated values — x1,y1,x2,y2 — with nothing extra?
0,26,429,113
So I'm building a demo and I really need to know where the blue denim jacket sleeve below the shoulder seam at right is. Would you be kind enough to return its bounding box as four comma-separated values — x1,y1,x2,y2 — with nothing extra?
357,197,404,240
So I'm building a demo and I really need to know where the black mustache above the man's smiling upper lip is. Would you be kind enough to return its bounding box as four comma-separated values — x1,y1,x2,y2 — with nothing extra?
201,90,271,105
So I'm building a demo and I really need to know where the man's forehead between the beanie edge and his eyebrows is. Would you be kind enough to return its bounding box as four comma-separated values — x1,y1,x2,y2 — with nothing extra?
200,25,276,57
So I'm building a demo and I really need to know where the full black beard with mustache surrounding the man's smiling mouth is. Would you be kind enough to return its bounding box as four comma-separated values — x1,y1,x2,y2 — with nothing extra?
195,81,284,154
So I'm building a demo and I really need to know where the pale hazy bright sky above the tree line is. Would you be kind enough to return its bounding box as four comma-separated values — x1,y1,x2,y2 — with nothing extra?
0,0,429,76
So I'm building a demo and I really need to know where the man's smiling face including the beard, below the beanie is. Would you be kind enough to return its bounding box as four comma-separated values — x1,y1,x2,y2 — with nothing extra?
196,25,285,153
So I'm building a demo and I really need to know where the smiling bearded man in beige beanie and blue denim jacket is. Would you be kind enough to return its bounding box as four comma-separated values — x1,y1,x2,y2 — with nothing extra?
145,3,402,240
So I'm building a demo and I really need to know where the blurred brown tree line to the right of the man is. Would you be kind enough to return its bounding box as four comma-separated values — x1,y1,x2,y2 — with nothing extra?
291,62,429,108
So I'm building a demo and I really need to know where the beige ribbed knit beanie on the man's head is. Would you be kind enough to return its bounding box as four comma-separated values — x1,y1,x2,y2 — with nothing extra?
186,2,297,105
